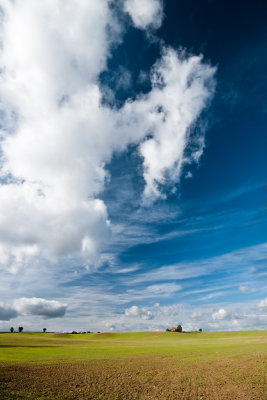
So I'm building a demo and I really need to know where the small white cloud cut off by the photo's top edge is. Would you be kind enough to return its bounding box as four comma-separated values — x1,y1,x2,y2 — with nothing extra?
124,0,163,29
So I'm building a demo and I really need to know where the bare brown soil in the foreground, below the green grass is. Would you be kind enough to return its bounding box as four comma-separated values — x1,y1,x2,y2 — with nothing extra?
0,355,267,400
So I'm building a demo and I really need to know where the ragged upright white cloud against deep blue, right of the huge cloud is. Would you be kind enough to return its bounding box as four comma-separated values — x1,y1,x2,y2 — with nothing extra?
140,48,215,199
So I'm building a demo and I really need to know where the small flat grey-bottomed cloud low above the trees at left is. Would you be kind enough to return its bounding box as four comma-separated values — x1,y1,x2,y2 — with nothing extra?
14,297,67,318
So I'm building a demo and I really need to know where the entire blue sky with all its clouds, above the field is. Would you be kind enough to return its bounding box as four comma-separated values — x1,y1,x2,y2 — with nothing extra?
0,0,267,332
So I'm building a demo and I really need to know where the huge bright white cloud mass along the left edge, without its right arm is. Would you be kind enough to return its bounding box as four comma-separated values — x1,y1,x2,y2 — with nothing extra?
0,0,114,270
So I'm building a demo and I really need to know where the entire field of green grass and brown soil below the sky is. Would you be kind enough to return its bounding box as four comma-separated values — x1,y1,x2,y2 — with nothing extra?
0,331,267,400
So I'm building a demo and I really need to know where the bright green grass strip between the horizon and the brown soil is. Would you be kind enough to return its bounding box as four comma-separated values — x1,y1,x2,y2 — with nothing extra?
0,331,267,364
